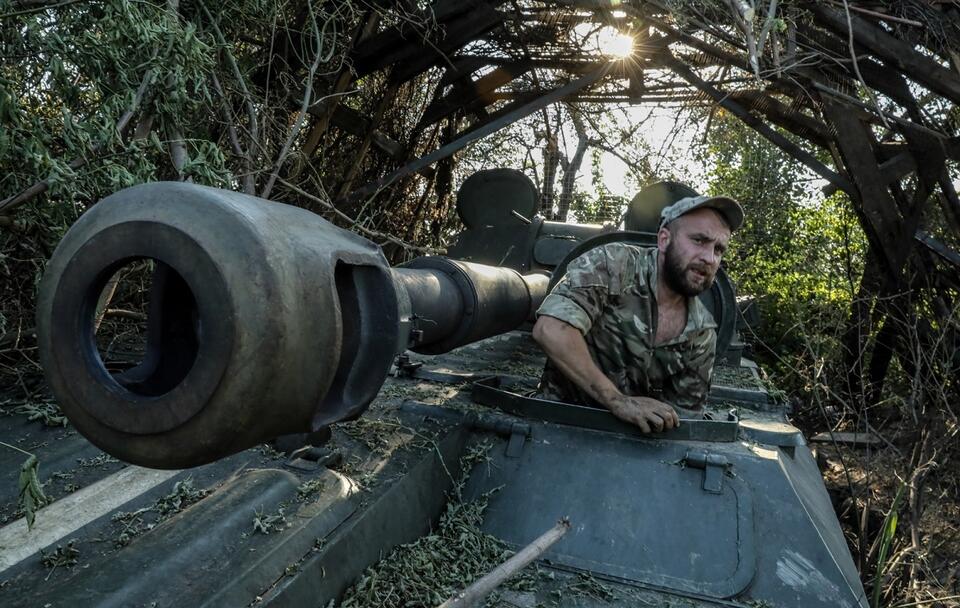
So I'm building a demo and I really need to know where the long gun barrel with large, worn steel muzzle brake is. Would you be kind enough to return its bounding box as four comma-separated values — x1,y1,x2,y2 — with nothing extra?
37,183,547,468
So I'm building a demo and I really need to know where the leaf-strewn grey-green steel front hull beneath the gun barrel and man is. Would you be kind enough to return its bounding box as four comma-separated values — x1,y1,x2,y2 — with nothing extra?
0,333,866,607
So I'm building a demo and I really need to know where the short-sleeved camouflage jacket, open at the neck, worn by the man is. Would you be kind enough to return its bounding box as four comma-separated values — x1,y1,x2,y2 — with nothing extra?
537,243,717,410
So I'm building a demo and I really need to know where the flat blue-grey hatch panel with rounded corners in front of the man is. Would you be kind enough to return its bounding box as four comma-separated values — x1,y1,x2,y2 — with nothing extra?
468,420,756,599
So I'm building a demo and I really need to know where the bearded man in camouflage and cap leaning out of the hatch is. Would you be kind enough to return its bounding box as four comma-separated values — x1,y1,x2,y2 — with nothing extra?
533,196,743,433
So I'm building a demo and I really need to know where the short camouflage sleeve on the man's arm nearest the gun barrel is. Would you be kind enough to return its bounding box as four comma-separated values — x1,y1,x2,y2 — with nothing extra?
537,247,611,335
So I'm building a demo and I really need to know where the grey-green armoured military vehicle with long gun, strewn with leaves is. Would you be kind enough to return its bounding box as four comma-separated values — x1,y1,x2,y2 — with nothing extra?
0,170,867,608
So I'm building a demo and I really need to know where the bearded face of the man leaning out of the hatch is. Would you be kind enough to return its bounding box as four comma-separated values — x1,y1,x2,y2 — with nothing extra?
657,209,730,297
